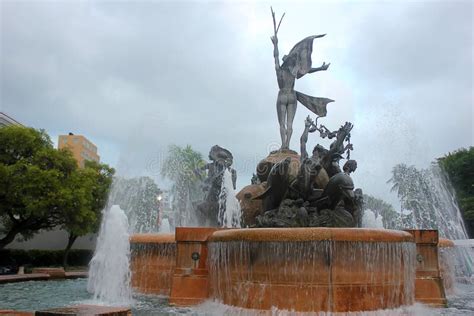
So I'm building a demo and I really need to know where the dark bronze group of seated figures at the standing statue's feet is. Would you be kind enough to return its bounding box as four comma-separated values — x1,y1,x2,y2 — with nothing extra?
255,117,363,227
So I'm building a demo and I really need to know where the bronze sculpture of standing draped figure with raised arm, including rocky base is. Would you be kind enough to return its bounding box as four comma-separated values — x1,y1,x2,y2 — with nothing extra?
238,9,363,227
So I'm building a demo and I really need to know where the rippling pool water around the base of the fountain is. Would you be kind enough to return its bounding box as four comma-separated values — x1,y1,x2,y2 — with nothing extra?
0,279,474,316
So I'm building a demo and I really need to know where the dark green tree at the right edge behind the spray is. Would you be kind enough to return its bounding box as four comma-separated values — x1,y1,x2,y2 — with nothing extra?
438,147,474,238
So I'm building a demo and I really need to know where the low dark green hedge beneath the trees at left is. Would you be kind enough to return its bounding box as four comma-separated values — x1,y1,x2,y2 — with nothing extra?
0,249,94,267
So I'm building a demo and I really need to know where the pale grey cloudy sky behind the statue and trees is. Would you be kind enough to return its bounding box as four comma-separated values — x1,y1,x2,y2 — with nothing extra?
0,0,474,206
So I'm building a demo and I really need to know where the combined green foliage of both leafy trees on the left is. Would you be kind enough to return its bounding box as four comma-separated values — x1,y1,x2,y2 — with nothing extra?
0,126,113,248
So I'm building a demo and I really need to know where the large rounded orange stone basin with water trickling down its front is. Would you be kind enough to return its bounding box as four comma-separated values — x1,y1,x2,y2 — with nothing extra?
208,228,416,312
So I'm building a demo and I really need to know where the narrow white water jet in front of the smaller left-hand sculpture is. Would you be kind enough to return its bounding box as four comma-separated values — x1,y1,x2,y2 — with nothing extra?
218,169,241,228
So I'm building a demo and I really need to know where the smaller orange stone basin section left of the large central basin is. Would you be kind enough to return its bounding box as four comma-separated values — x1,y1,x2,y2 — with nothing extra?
130,234,176,295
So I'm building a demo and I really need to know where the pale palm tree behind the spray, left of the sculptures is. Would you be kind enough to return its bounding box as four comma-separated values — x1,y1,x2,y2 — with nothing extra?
161,145,205,226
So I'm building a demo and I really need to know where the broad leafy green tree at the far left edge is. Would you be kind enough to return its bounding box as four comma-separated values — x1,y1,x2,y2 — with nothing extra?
0,126,75,249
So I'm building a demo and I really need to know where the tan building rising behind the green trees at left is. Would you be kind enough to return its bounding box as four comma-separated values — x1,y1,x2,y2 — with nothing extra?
58,133,100,168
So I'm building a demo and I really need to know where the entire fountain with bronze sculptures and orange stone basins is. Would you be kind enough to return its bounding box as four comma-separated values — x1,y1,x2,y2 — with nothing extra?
127,7,452,313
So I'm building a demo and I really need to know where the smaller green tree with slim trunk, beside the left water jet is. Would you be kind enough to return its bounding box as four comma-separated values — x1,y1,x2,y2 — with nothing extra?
62,161,115,267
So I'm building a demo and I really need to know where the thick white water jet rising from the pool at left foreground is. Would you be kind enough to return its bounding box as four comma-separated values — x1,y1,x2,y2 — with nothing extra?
87,205,132,305
